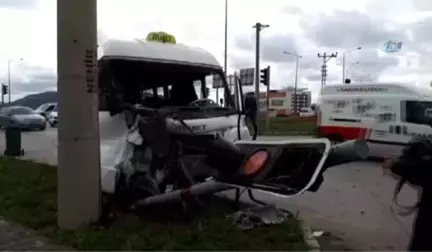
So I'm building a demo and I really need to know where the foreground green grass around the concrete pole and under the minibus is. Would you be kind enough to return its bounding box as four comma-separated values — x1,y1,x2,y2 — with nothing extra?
0,157,308,252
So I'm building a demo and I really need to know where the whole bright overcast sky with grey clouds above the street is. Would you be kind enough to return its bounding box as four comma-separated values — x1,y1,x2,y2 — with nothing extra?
0,0,432,99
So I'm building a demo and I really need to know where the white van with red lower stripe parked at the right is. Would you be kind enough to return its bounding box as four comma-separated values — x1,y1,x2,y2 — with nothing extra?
318,83,432,157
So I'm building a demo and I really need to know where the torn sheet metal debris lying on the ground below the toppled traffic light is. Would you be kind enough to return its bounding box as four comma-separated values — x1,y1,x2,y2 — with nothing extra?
229,205,293,231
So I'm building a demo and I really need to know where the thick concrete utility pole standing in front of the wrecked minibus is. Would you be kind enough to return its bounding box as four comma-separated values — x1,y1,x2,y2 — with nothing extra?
57,0,101,229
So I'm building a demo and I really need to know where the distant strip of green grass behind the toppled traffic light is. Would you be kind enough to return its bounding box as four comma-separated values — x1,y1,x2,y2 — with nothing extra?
258,117,316,136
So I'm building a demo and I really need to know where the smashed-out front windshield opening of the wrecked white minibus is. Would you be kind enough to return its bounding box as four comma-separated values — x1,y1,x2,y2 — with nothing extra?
108,60,233,108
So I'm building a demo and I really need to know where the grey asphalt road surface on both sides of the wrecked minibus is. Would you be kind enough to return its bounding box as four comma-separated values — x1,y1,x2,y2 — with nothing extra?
0,128,417,252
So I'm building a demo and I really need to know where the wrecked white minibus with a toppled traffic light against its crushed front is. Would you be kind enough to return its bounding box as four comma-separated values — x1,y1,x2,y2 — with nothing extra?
98,34,368,210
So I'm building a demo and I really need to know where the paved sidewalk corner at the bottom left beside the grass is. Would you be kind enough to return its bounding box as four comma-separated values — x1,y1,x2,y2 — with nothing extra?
0,217,77,252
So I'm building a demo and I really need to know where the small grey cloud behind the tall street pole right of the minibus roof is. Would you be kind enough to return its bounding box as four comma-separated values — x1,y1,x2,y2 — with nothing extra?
235,34,298,63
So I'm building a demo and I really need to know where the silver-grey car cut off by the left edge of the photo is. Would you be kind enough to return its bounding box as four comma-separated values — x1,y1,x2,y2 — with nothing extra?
0,106,46,130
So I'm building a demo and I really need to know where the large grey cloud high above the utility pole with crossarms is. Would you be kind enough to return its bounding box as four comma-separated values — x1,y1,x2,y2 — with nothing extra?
301,11,408,48
